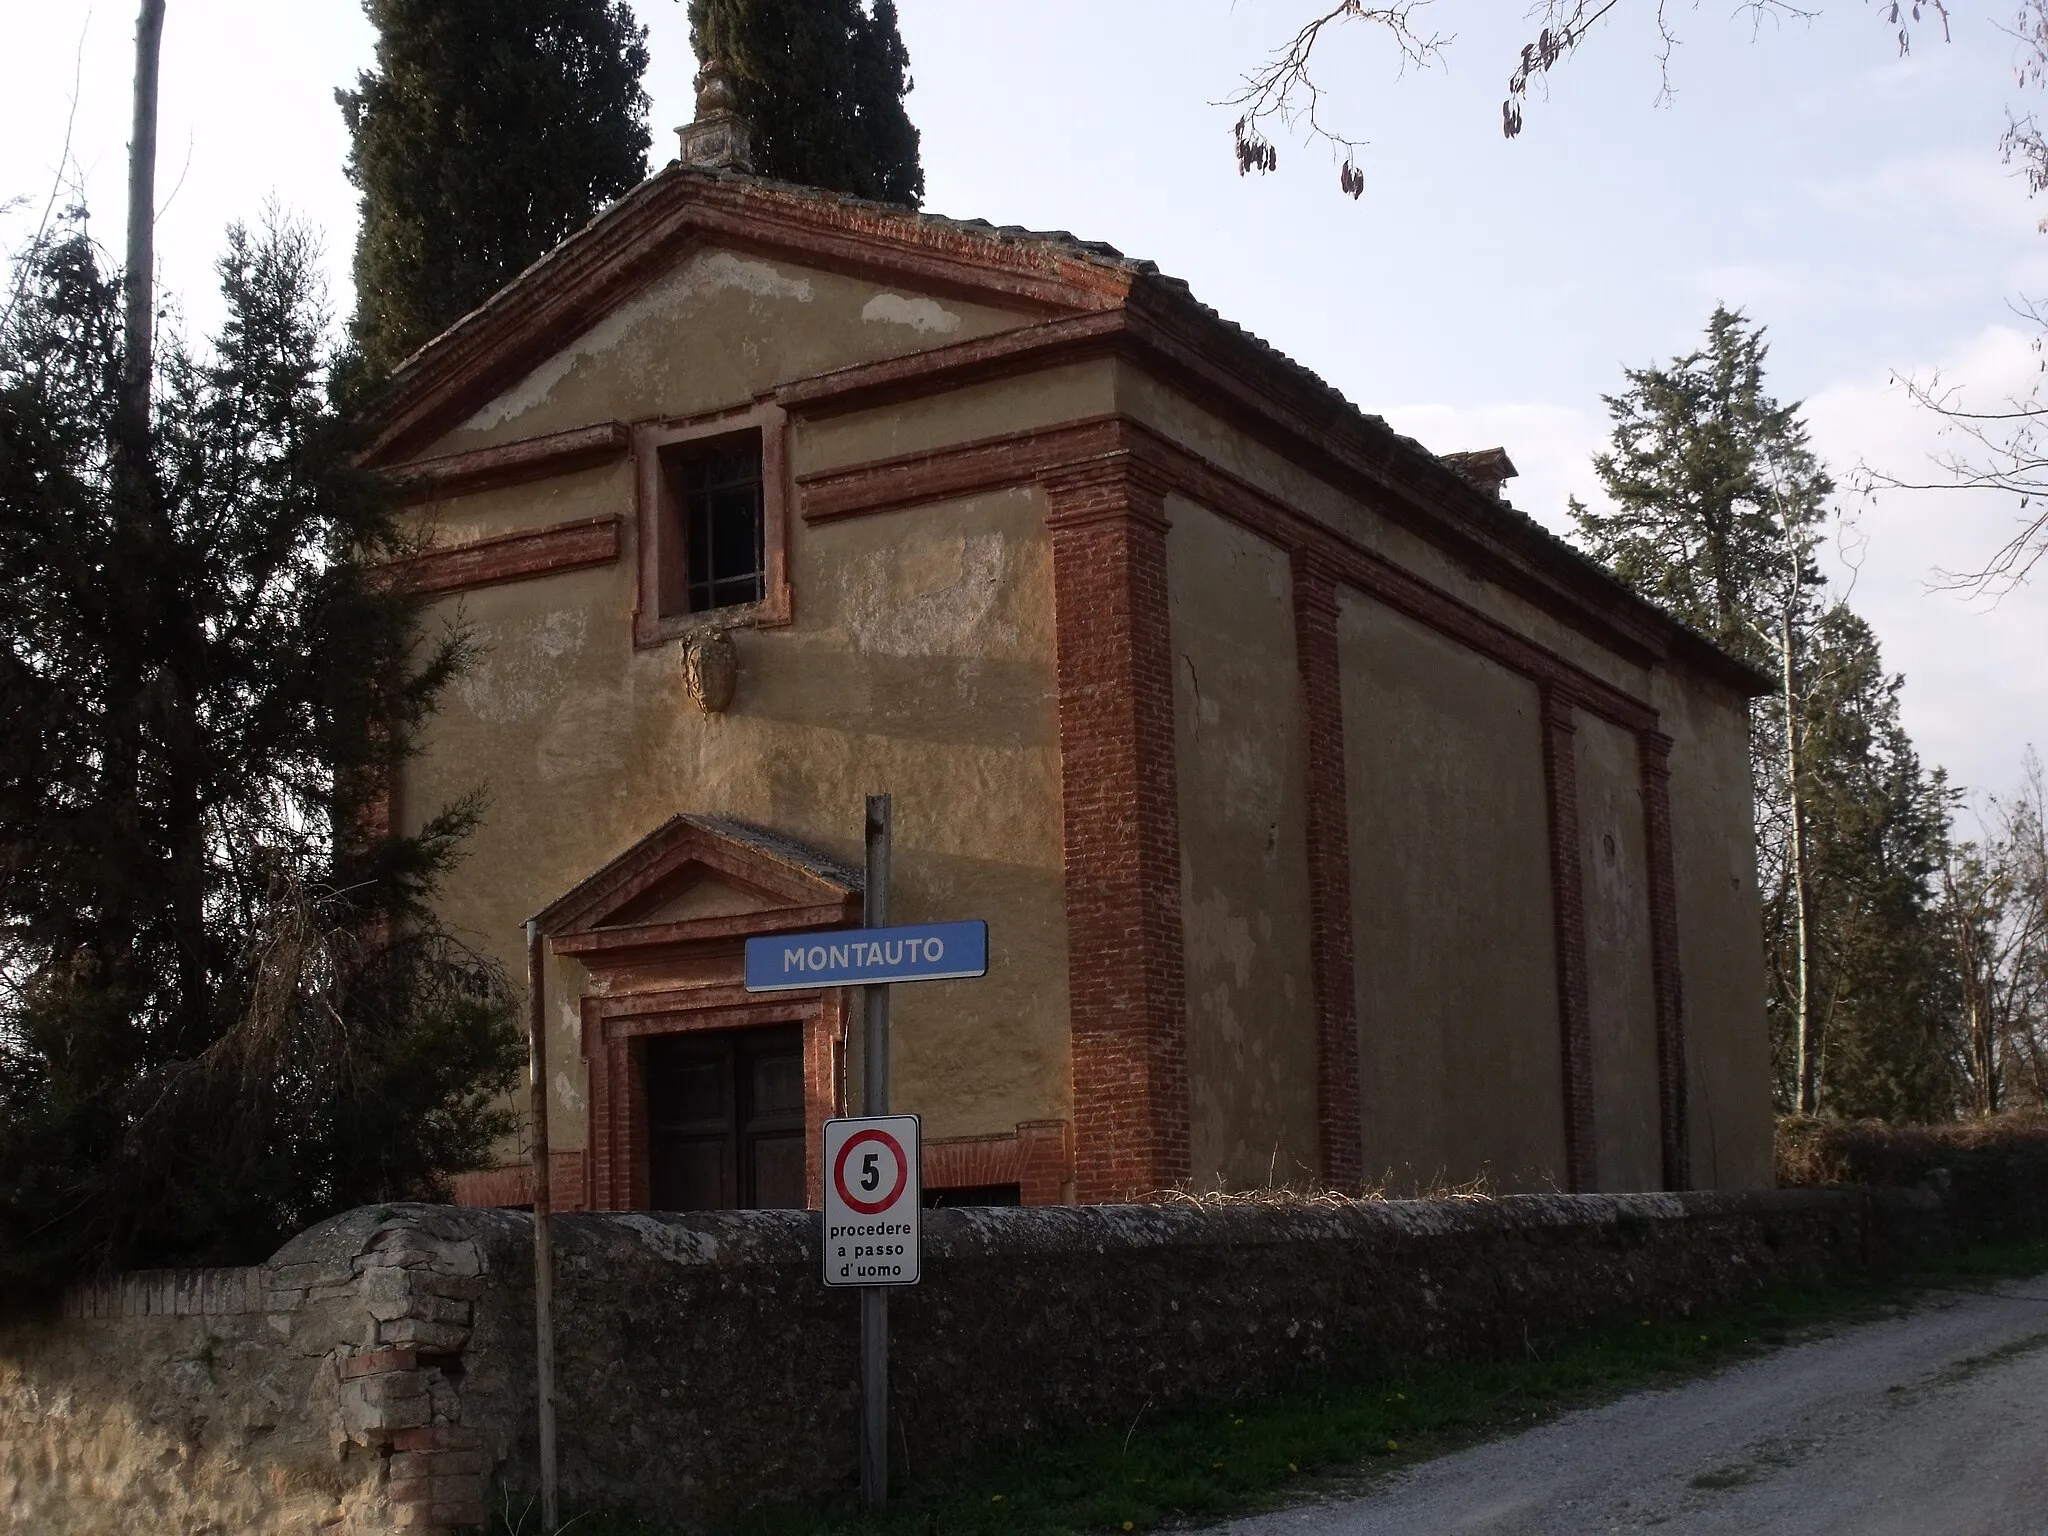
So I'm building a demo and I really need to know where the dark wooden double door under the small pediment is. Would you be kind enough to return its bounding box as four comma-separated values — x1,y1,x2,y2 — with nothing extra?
645,1024,809,1210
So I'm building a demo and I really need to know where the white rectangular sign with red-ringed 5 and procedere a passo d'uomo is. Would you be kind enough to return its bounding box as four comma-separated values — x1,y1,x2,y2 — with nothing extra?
825,1114,924,1286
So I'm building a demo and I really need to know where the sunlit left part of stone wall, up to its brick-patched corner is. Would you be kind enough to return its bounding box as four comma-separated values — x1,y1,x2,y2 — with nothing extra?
0,1206,495,1536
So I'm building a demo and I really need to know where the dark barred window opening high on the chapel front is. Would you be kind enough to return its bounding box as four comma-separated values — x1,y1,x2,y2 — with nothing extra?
662,432,768,614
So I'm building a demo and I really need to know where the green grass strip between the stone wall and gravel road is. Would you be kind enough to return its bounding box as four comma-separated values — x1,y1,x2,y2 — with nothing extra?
494,1237,2048,1536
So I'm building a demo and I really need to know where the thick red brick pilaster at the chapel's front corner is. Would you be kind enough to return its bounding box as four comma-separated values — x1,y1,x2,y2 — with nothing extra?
1042,453,1190,1202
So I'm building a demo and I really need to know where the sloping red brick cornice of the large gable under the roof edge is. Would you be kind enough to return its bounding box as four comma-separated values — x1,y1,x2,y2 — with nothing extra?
369,166,1149,465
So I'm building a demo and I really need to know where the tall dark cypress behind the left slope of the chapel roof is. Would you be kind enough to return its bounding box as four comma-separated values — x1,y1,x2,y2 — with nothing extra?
336,0,647,369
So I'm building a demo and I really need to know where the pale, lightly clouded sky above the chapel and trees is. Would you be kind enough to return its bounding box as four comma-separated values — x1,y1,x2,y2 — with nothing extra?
0,0,2048,811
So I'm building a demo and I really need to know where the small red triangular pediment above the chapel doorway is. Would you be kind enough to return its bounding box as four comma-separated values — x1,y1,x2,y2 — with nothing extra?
535,815,860,954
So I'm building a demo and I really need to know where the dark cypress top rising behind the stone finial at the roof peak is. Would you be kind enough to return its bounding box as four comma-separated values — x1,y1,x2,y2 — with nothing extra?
690,0,924,207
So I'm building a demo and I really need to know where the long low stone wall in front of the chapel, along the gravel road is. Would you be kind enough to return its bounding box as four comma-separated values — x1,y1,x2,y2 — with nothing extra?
0,1169,2048,1536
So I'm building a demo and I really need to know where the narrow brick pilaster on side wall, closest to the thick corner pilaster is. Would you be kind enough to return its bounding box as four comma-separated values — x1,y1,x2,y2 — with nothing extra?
1294,551,1364,1192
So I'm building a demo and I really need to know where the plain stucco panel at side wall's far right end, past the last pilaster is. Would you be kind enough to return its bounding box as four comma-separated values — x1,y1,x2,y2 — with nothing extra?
1655,678,1772,1190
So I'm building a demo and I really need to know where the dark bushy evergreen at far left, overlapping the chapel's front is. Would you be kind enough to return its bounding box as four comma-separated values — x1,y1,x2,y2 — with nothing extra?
0,214,520,1294
